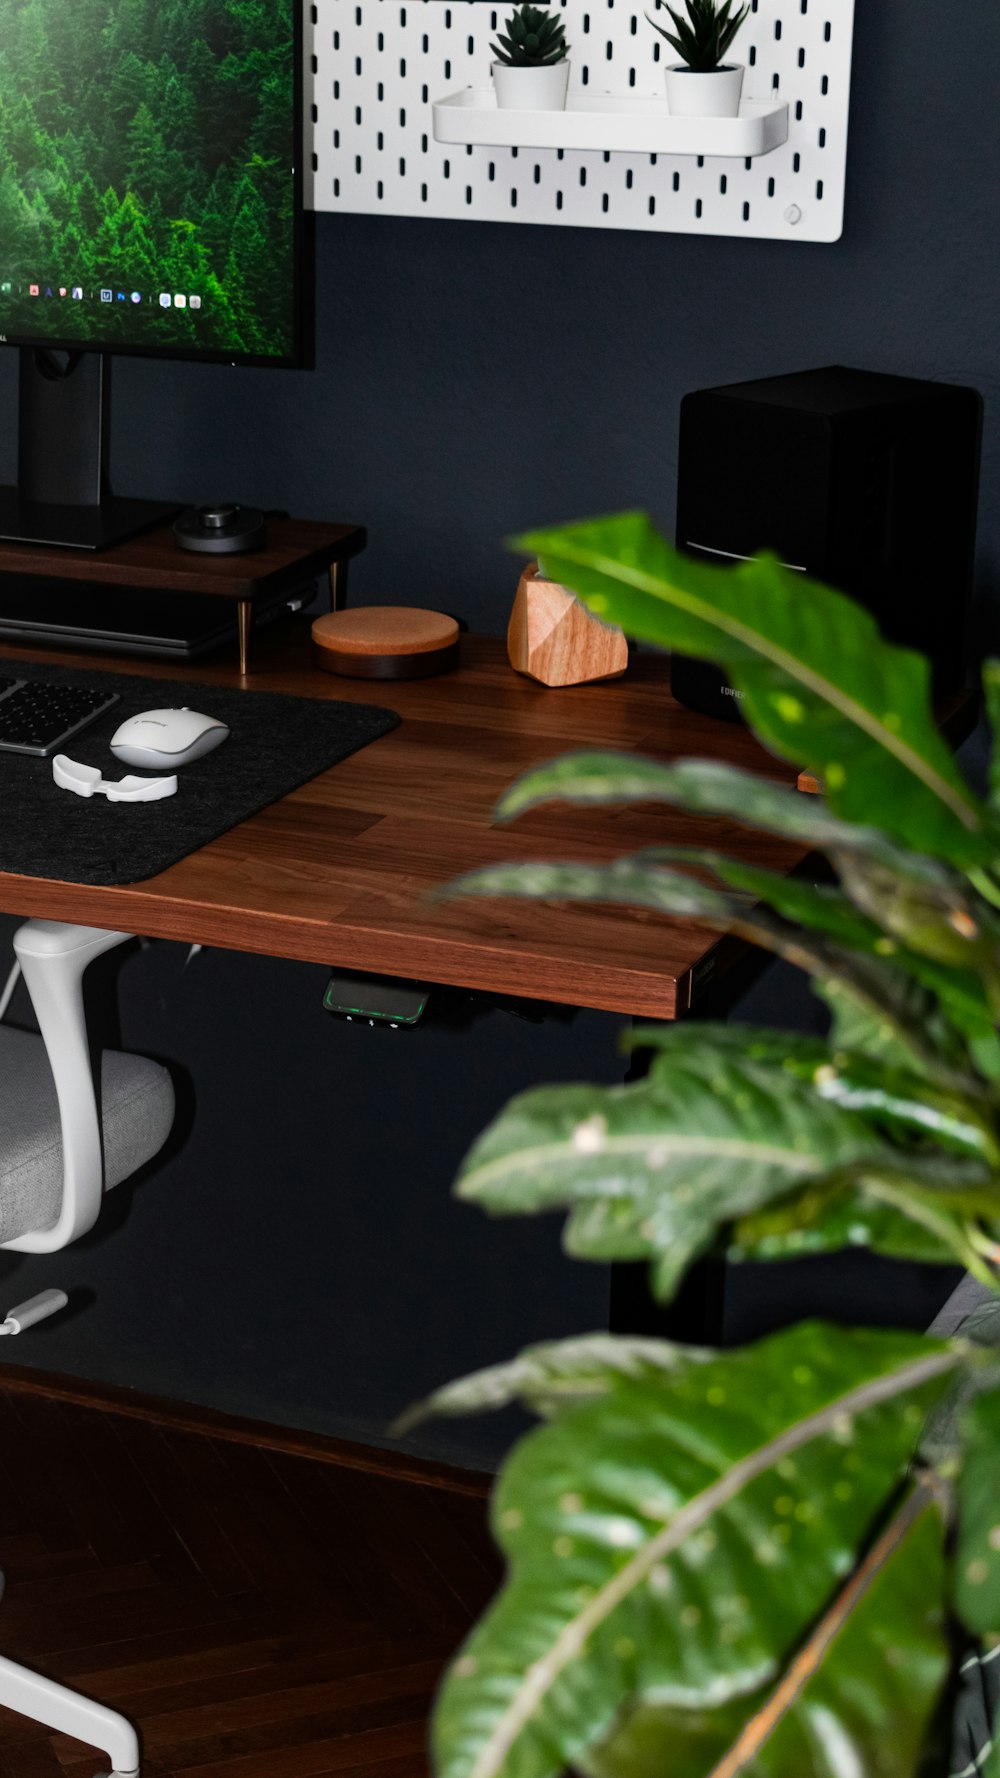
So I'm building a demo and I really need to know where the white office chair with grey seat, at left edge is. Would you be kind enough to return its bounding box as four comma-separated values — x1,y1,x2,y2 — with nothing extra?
0,919,174,1778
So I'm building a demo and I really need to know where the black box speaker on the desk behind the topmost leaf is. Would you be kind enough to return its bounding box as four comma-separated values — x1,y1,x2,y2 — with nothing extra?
671,364,982,720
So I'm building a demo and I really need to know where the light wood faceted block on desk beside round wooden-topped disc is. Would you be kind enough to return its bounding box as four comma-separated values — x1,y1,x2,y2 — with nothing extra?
507,562,628,685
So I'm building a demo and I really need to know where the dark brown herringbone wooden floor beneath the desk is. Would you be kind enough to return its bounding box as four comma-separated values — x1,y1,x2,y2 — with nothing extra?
0,1387,498,1778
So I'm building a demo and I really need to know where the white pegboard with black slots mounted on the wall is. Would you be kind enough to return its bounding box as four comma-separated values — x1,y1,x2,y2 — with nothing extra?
306,0,854,242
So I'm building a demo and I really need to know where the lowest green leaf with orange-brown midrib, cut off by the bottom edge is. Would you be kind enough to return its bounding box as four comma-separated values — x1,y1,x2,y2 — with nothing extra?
578,1492,948,1778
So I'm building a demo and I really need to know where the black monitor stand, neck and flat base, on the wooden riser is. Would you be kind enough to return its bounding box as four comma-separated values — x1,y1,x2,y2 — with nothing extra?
0,347,178,549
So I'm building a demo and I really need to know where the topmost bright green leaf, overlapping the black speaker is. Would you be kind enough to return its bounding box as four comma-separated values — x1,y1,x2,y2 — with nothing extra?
514,512,995,868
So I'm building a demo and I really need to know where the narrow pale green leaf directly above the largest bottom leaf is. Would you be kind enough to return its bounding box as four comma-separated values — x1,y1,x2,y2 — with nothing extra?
393,1334,712,1433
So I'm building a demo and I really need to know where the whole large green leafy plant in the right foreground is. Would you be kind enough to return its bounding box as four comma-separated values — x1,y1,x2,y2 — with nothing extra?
412,514,1000,1778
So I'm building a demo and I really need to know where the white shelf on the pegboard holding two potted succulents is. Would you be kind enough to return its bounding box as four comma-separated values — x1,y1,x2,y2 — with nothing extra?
432,87,788,160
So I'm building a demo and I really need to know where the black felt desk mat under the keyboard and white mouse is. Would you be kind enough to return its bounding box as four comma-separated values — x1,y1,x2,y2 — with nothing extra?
0,661,400,885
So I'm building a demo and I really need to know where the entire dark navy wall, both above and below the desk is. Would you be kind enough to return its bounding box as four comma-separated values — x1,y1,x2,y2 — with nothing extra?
0,0,1000,1460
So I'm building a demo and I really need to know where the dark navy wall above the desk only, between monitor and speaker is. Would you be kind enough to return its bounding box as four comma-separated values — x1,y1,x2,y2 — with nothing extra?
4,0,1000,629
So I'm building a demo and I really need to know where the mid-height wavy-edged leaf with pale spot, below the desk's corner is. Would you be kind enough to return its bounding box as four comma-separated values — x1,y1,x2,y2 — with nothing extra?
456,1045,895,1294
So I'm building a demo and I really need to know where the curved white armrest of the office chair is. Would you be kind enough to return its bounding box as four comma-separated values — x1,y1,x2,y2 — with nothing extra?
4,919,130,1253
